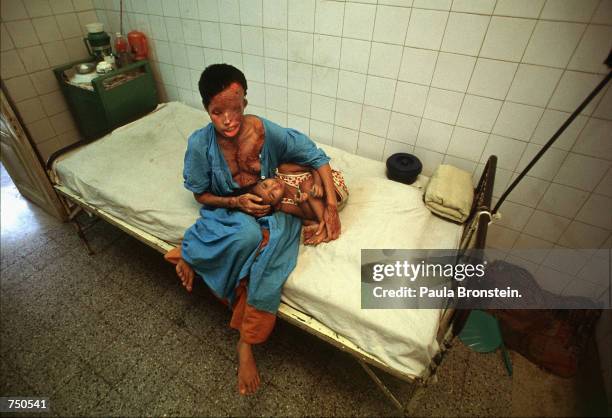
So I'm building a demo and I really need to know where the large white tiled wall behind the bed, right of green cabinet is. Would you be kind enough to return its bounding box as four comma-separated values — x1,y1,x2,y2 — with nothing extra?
94,0,612,258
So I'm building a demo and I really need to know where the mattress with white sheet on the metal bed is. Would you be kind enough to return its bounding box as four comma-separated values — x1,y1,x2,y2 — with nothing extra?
54,103,461,376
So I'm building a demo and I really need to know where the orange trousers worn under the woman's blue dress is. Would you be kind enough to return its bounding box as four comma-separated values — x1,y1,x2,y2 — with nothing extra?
164,229,276,344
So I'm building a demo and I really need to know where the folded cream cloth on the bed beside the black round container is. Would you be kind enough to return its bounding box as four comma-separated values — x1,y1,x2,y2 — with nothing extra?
424,164,474,222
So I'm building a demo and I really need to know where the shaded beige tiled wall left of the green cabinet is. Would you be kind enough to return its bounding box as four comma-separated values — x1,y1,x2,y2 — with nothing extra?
0,0,97,159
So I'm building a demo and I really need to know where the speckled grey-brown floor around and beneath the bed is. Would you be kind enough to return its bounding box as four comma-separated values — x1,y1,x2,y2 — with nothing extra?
0,164,608,416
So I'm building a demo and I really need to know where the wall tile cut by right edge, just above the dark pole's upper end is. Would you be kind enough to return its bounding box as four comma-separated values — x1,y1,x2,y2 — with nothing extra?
567,25,612,74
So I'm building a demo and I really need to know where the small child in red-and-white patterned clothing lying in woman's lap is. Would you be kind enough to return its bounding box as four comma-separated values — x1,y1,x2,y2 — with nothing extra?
250,163,349,245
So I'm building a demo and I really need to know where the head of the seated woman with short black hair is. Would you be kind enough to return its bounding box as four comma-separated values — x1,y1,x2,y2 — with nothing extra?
198,64,247,138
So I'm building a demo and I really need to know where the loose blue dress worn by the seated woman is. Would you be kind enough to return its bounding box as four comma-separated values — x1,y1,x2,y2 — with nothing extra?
181,118,329,313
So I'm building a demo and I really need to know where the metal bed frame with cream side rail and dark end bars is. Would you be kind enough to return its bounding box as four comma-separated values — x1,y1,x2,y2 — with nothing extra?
47,143,497,413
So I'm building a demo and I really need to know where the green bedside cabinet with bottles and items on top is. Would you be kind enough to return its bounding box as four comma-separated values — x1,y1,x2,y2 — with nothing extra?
53,60,159,140
